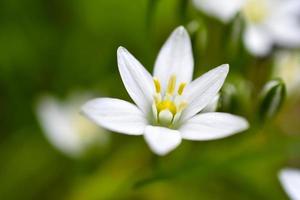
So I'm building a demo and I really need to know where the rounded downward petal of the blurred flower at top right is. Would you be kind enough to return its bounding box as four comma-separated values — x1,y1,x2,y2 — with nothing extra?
243,25,273,56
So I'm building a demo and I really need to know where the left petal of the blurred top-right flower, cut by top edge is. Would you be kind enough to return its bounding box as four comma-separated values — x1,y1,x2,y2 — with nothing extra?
194,0,245,22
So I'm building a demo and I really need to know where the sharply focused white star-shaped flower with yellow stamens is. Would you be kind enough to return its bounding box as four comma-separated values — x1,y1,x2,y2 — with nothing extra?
82,27,248,155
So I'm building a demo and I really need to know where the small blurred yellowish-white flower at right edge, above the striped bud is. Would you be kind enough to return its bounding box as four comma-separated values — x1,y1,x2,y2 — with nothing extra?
273,51,300,94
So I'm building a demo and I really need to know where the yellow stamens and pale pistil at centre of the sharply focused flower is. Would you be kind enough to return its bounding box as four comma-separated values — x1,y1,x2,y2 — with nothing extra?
152,75,187,128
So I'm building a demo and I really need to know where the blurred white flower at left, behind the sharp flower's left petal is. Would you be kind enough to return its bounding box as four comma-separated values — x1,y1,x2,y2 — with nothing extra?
36,94,108,157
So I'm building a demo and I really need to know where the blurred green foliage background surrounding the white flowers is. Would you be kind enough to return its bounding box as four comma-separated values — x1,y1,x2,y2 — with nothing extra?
0,0,300,200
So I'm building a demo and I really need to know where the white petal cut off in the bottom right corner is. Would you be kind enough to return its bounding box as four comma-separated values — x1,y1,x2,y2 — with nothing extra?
279,168,300,200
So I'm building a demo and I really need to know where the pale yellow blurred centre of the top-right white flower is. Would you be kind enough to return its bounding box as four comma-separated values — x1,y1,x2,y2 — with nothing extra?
243,0,268,23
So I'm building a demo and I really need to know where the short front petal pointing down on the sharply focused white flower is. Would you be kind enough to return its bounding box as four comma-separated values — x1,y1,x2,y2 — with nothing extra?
144,126,181,156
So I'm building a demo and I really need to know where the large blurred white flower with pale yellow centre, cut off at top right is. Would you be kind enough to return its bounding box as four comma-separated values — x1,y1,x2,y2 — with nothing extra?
194,0,300,56
